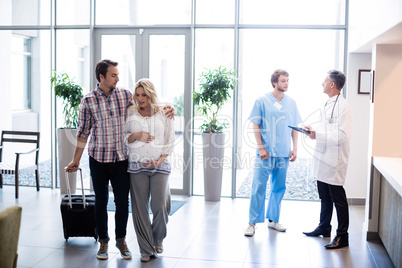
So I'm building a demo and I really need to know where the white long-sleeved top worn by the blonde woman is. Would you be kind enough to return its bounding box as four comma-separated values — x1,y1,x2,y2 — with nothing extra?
125,107,175,174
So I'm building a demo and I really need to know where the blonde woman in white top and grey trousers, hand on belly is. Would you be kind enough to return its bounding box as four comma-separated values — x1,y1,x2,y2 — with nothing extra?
126,78,174,262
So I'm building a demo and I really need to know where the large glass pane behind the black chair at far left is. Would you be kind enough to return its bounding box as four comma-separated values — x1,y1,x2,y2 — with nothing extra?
0,29,52,187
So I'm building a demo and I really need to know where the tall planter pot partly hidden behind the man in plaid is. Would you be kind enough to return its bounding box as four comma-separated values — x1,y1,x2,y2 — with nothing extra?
57,128,77,195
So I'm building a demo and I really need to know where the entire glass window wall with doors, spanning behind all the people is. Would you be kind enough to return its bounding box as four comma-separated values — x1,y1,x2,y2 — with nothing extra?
0,0,348,199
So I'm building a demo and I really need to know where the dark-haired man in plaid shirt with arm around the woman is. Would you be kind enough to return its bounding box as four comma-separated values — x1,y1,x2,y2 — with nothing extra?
66,60,174,260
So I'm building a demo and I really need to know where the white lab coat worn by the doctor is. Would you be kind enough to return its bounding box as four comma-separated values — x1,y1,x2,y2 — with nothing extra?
313,95,352,186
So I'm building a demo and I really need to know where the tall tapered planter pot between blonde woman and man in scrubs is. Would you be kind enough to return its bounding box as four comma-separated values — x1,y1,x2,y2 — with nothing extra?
202,133,225,202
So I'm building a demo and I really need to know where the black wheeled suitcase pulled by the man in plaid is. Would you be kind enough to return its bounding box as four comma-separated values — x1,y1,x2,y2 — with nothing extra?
60,168,98,241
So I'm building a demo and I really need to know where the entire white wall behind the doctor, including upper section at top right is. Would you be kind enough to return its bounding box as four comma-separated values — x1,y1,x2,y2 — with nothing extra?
345,0,402,199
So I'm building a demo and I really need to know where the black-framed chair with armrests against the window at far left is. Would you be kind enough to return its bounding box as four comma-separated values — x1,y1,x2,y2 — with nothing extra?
0,130,40,198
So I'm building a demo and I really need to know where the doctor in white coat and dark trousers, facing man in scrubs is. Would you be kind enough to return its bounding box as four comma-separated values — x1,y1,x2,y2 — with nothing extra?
304,70,352,249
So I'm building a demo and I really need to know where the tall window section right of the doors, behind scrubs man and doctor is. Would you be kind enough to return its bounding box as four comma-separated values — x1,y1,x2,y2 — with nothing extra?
193,0,346,200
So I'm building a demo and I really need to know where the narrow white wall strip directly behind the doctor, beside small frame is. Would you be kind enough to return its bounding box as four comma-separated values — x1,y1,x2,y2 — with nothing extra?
345,53,371,199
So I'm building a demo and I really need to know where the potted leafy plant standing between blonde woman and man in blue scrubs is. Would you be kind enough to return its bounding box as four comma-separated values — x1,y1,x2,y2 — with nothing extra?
193,66,237,201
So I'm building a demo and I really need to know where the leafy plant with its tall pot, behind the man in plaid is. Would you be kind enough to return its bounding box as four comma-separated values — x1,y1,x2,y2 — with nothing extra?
50,71,83,194
